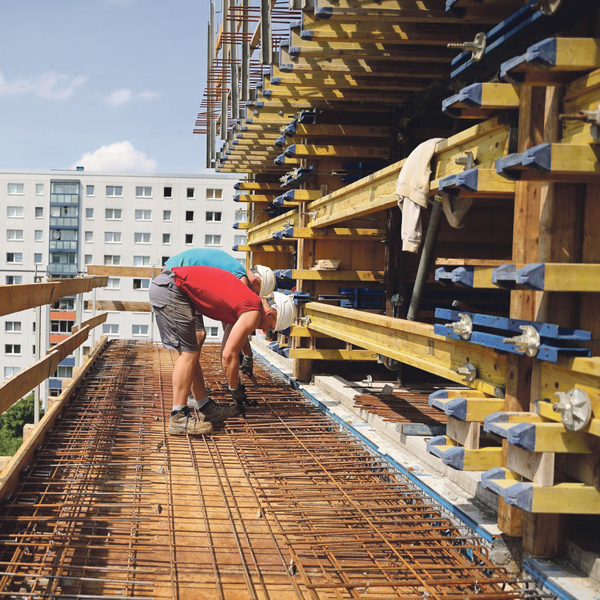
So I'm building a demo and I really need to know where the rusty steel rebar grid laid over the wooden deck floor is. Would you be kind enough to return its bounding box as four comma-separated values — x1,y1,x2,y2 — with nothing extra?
0,341,543,600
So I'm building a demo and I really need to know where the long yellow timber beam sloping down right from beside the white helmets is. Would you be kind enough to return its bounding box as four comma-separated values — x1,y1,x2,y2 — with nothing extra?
304,302,506,394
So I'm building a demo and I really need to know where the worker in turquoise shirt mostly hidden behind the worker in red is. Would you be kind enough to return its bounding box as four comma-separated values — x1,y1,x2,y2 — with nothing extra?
165,248,275,384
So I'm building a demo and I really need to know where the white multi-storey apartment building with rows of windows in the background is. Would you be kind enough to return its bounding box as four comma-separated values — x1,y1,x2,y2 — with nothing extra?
0,168,246,395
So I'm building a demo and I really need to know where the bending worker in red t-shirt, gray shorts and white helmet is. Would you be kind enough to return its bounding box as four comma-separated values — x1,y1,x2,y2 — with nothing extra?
150,266,296,435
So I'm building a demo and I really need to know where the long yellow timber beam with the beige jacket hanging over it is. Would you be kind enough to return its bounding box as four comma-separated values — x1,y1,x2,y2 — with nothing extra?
307,117,510,228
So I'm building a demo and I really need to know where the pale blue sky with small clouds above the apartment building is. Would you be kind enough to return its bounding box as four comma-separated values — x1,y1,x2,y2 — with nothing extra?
0,0,209,173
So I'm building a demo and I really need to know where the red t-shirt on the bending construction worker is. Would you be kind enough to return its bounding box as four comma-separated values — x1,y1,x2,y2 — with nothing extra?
171,266,261,323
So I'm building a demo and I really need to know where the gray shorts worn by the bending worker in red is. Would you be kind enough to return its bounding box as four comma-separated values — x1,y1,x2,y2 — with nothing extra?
149,271,204,352
